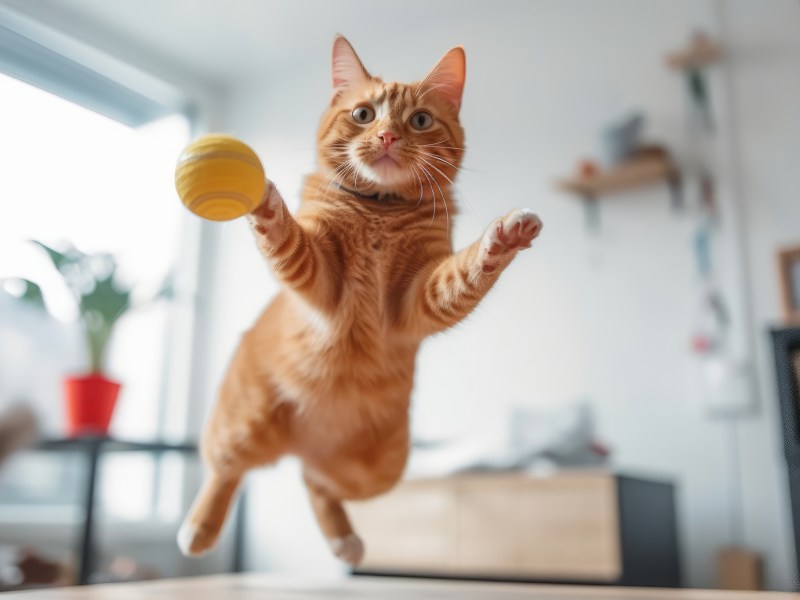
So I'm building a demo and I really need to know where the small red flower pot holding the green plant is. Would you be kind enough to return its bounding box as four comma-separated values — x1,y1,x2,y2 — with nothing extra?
64,373,121,437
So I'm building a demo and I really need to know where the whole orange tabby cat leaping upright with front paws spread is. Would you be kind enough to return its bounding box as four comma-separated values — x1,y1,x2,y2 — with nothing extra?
178,37,541,565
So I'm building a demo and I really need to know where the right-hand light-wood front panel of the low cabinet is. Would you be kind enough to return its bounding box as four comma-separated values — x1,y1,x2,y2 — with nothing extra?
457,475,622,581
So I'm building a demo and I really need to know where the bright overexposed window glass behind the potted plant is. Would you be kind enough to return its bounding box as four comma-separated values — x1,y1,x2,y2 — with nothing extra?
0,69,189,518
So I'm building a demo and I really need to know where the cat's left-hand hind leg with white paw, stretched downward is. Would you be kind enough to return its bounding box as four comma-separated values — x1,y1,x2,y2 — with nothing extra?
178,473,241,556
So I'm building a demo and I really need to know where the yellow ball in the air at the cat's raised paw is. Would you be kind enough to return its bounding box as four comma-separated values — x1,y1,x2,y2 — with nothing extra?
175,134,266,221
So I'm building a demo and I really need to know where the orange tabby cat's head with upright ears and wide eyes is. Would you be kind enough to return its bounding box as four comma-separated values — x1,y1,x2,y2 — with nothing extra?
317,36,466,200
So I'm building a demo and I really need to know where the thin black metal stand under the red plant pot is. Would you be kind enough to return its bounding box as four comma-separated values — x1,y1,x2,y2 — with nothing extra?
36,437,230,585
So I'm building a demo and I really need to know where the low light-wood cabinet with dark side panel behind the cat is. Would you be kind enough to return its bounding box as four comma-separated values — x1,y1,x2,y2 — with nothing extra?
349,472,679,585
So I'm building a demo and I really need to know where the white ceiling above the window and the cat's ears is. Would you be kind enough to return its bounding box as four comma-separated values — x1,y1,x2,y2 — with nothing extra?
0,0,488,91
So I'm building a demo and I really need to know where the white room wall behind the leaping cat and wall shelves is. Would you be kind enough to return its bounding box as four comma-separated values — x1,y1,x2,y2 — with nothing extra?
197,0,800,589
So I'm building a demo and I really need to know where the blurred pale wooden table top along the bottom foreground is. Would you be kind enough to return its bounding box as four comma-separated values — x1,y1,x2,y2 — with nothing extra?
0,573,800,600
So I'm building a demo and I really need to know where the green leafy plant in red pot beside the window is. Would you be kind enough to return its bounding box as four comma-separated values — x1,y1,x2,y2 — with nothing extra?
24,241,168,436
